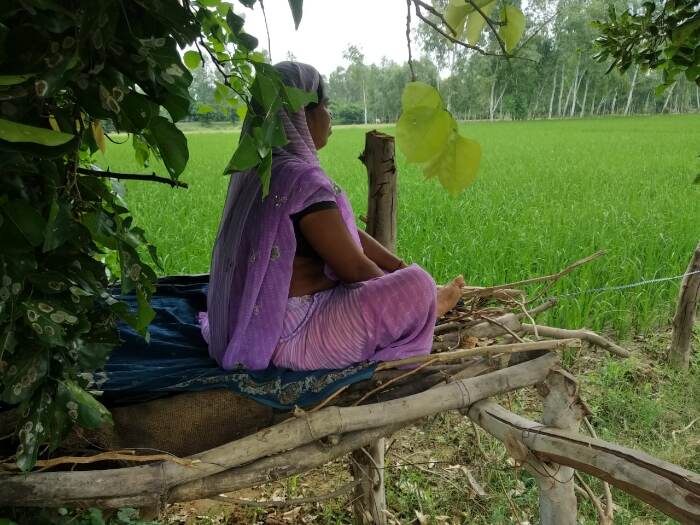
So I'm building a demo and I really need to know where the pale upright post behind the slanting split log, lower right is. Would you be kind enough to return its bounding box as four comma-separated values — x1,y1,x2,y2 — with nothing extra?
529,369,584,525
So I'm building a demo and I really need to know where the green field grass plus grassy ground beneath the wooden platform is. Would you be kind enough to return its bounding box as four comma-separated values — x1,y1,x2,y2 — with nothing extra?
98,115,700,525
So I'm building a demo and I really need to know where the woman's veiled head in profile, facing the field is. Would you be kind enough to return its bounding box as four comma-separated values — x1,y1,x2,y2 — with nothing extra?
275,62,332,150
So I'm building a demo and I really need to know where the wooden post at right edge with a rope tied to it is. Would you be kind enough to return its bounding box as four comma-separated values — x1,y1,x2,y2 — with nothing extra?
668,243,700,370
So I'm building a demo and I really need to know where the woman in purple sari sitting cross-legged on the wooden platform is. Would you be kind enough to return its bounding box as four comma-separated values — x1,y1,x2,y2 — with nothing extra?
200,62,464,370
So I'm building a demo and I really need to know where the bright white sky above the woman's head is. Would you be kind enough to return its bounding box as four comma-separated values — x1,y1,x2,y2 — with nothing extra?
241,0,419,76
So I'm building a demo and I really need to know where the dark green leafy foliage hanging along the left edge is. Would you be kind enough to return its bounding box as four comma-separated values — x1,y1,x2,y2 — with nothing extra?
0,0,308,470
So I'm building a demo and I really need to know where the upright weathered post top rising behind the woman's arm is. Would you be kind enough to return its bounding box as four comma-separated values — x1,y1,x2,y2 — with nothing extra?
359,130,397,252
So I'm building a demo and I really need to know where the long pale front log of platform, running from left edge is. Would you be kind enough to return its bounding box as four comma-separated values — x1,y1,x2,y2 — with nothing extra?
0,354,564,508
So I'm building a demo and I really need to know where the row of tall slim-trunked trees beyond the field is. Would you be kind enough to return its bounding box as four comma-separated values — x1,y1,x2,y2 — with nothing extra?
308,0,700,124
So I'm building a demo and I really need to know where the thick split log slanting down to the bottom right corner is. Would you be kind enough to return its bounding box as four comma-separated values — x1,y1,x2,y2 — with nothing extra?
468,400,700,523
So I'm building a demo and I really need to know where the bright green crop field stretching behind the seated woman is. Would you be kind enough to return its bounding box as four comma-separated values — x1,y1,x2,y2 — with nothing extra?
104,115,700,333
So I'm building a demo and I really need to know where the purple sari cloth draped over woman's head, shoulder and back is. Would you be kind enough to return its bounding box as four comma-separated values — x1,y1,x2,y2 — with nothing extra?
204,62,360,370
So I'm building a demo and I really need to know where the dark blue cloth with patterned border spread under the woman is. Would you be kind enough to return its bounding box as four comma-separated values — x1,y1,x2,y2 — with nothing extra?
97,275,376,409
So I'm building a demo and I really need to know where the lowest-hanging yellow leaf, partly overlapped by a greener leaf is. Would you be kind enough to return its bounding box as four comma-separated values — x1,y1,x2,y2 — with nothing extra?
423,133,481,196
